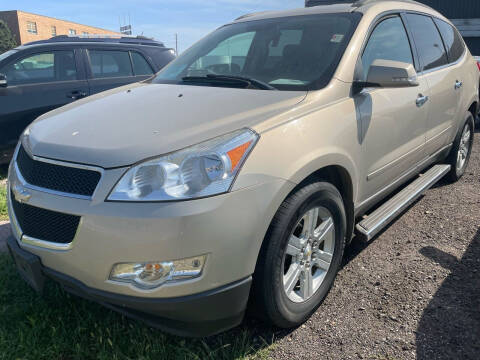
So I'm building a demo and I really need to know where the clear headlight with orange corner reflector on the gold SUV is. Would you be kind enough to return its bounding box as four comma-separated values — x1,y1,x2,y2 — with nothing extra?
108,129,258,201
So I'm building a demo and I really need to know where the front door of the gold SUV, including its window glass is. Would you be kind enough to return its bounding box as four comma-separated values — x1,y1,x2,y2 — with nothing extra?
354,15,429,200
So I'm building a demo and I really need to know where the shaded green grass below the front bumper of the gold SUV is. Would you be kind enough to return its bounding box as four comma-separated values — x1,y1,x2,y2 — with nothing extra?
0,253,273,360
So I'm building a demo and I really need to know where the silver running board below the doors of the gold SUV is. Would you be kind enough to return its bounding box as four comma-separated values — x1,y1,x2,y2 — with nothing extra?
356,165,451,240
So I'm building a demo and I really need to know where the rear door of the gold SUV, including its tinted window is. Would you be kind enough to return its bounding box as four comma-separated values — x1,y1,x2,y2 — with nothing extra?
405,13,464,155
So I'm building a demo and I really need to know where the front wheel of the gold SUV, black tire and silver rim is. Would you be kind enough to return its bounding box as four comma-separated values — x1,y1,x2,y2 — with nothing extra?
253,182,346,328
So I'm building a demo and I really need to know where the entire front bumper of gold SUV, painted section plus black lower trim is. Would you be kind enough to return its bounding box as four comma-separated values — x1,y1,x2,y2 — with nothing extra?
7,148,295,336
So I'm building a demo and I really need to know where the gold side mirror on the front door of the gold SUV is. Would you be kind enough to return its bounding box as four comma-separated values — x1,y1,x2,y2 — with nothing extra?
357,60,419,88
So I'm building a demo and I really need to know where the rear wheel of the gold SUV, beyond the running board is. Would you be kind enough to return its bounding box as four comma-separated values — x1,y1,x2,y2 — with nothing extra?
447,112,475,182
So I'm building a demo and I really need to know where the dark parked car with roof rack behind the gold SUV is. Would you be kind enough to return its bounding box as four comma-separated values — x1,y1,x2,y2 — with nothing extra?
0,36,175,164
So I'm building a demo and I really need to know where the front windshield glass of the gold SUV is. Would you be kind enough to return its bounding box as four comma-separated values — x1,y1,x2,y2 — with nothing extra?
152,13,361,90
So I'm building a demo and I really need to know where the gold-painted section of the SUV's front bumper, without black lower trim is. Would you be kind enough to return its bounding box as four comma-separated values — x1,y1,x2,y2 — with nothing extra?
8,174,290,298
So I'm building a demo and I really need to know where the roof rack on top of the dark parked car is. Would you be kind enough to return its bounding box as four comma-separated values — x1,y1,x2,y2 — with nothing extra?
25,35,165,47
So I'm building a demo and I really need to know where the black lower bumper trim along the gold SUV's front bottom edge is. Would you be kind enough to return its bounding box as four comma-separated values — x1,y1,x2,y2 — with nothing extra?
7,237,252,337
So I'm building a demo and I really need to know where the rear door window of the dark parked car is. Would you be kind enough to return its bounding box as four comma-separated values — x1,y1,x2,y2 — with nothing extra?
88,50,133,78
